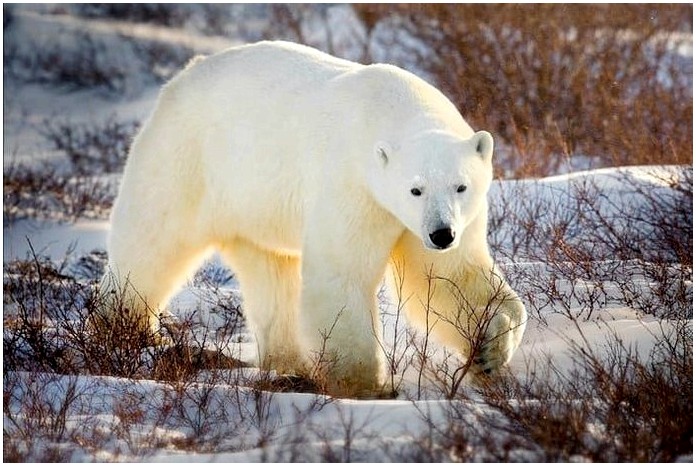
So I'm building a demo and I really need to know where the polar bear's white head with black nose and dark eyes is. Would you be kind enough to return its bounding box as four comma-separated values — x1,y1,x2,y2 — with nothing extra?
368,130,493,251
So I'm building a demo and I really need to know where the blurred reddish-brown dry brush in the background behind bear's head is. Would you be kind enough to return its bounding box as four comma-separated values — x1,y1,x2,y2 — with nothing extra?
355,4,693,177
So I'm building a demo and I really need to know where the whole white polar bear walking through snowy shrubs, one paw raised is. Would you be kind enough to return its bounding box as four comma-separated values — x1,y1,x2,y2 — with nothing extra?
102,42,526,393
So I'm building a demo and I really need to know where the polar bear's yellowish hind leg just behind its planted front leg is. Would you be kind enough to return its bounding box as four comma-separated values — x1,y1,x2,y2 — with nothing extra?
220,240,303,374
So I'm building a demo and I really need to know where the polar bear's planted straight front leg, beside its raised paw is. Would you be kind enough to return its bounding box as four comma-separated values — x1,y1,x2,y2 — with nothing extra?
300,195,402,397
